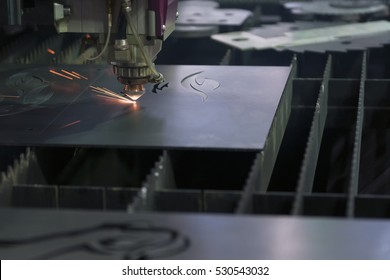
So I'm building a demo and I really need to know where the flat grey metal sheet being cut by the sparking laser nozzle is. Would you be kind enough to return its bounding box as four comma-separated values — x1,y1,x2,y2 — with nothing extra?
0,66,290,150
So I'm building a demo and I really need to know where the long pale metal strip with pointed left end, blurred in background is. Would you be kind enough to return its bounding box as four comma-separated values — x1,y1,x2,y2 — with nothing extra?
212,21,390,52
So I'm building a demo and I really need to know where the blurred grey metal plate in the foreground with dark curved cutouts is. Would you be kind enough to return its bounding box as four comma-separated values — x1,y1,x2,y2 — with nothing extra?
0,209,390,260
